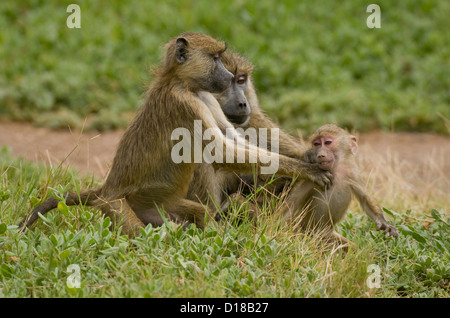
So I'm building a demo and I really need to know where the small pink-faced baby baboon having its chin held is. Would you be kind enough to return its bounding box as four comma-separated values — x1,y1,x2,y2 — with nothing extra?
282,124,398,244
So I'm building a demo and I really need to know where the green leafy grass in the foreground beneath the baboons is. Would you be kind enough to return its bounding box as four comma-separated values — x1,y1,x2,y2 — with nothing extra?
0,148,450,297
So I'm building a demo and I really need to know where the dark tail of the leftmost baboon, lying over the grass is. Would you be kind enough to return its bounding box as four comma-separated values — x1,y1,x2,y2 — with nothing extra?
19,190,98,229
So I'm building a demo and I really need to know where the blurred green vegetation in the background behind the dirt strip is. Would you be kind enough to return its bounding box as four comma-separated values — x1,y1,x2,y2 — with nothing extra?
0,0,450,134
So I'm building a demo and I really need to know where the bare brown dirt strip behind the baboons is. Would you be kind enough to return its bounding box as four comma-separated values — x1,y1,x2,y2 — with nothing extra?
0,122,450,183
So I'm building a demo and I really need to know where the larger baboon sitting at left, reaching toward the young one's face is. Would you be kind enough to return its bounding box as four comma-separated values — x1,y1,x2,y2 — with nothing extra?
21,33,332,236
